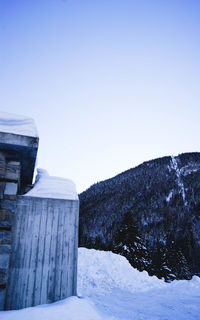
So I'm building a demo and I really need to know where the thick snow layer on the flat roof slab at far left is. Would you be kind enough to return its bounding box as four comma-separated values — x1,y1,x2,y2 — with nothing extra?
0,111,38,137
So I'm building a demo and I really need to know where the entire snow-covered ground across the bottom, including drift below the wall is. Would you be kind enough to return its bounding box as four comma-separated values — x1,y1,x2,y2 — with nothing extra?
0,248,200,320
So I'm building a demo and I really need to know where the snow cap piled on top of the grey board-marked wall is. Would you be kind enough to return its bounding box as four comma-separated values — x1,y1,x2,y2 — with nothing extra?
24,169,78,200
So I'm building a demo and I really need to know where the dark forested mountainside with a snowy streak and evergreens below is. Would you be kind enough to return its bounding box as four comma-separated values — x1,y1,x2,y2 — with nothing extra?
79,152,200,281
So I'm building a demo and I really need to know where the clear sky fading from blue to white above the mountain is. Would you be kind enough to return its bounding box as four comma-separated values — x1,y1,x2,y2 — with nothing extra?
0,0,200,192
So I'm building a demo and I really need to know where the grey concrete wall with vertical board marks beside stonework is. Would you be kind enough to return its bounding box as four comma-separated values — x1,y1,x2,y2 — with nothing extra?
5,196,79,310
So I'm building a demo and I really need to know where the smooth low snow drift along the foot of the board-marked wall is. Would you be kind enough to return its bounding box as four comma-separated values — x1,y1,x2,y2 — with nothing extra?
0,297,102,320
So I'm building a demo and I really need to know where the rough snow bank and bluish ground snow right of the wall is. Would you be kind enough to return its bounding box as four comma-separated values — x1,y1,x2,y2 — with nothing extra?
78,248,200,320
